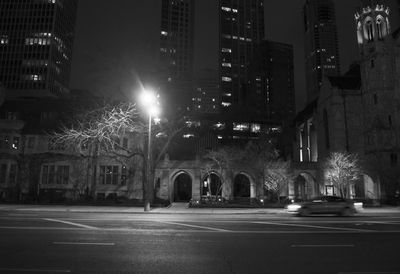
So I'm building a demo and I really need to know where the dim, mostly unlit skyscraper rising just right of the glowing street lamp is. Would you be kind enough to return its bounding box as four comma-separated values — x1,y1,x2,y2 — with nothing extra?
160,0,195,116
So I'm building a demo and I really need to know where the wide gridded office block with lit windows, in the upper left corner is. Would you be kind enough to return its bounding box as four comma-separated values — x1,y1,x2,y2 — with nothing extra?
0,0,78,98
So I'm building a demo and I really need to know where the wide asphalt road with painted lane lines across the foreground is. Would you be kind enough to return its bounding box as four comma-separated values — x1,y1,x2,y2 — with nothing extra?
0,211,400,274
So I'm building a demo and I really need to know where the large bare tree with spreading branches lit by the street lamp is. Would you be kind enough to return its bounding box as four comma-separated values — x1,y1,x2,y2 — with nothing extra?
50,103,181,208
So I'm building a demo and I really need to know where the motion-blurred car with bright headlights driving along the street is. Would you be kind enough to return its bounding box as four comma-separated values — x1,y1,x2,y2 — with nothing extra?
287,196,362,216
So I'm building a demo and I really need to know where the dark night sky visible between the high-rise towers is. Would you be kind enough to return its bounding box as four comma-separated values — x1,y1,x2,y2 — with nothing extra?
71,0,398,111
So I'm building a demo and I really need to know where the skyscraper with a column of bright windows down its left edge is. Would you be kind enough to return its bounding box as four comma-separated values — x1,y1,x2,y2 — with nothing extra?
219,0,265,119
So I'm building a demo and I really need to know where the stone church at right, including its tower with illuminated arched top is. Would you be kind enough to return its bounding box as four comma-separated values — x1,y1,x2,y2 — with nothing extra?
294,1,400,203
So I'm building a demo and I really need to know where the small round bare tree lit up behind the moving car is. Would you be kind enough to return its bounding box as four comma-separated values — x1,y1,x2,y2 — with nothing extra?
323,152,361,198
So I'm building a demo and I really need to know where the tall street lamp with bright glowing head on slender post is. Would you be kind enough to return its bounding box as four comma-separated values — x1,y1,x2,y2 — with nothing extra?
140,90,160,211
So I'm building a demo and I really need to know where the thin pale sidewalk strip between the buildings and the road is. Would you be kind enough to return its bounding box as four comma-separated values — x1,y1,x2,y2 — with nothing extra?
0,204,400,214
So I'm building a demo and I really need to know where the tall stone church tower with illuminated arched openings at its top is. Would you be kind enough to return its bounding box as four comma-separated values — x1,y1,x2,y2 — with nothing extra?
355,0,400,197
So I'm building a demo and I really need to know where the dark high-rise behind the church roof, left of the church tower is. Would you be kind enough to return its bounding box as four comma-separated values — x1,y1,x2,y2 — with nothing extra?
303,0,340,102
